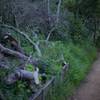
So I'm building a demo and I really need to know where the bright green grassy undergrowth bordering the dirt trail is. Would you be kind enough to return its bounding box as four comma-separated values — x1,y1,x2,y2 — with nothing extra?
45,42,96,100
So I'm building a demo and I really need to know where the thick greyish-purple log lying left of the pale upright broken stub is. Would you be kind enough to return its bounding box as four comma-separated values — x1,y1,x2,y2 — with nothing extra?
0,63,35,85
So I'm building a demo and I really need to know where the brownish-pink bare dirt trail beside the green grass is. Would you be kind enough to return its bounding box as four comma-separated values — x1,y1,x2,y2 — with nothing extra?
69,53,100,100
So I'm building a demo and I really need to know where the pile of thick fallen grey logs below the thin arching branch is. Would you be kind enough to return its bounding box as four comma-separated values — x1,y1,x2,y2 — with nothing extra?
0,30,41,84
